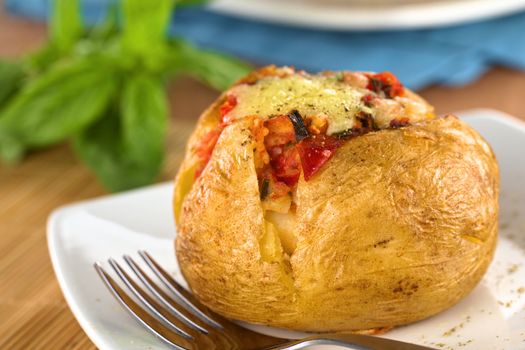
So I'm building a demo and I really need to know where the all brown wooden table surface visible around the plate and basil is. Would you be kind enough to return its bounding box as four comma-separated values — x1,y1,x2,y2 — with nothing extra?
0,4,525,350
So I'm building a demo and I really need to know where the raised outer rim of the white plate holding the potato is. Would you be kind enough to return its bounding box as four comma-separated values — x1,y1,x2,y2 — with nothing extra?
47,109,525,349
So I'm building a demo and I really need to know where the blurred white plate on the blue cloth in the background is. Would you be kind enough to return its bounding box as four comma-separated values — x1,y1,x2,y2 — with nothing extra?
210,0,525,30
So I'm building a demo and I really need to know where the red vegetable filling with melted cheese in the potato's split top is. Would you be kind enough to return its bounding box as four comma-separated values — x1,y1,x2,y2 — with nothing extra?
176,66,435,219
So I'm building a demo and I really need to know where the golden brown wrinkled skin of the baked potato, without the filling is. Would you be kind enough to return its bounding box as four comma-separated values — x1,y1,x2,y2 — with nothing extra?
175,110,499,332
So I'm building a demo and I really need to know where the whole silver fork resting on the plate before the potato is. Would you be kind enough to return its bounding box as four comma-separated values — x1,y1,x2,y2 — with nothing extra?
94,251,430,350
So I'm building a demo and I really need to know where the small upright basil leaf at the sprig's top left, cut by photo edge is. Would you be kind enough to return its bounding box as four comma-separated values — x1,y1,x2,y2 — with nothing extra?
50,0,83,50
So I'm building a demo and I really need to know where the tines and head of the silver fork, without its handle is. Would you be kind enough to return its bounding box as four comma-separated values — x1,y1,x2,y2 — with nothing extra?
94,251,234,349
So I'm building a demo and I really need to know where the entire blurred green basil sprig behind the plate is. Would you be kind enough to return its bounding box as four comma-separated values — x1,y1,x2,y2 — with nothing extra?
0,0,250,191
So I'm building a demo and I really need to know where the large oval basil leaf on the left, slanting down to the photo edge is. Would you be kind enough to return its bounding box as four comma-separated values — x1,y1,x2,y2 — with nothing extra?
0,60,118,161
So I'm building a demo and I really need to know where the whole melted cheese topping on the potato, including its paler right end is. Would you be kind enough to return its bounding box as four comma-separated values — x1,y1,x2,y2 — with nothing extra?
228,72,435,135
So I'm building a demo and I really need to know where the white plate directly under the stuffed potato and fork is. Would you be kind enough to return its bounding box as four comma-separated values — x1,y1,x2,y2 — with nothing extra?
48,110,525,350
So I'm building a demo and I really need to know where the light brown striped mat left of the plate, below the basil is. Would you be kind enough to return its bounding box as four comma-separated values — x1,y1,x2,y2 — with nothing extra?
0,115,205,349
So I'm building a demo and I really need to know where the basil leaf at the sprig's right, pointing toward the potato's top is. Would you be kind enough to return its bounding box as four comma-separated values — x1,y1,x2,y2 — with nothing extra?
171,40,253,91
